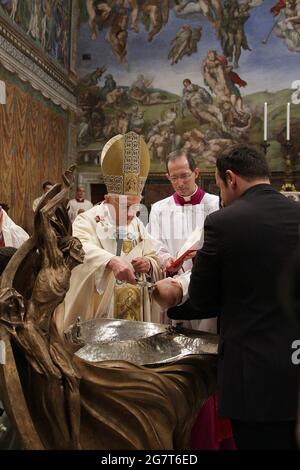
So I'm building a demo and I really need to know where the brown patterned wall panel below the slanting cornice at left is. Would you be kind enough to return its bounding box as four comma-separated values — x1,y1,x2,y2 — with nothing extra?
0,65,68,232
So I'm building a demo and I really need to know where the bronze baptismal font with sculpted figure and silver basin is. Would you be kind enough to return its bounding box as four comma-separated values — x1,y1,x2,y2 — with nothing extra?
0,168,217,450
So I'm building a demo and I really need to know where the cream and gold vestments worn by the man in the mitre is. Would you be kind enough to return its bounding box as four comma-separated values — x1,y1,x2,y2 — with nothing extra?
65,202,162,327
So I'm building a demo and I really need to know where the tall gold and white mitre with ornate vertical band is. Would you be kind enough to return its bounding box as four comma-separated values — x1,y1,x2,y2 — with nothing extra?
101,132,150,196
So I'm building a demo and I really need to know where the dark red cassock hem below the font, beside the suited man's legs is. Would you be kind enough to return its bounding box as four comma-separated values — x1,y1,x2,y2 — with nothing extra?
191,395,236,450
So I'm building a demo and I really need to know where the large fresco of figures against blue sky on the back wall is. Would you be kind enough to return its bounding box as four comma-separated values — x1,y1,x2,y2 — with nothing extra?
78,0,300,180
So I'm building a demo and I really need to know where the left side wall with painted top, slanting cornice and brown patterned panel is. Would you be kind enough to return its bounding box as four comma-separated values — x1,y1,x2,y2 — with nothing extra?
0,0,78,232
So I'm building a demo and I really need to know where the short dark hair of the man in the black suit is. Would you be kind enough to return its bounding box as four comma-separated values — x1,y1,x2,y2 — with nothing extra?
216,144,270,184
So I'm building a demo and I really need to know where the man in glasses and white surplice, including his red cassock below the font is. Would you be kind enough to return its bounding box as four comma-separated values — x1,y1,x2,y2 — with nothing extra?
147,150,235,450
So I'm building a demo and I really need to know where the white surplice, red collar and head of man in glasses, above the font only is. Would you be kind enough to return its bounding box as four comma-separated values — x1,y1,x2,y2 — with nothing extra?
147,150,219,331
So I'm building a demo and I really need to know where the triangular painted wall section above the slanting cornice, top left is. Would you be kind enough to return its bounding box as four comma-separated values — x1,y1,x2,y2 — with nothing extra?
0,0,71,69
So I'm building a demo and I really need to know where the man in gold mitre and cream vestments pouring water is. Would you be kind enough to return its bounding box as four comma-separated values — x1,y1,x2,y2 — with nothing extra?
64,132,162,329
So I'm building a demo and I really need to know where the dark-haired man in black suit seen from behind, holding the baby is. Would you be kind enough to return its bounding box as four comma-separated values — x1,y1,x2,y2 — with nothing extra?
157,145,300,449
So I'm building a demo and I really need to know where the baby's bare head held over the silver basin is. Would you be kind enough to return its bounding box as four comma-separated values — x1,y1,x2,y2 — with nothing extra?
153,277,182,308
